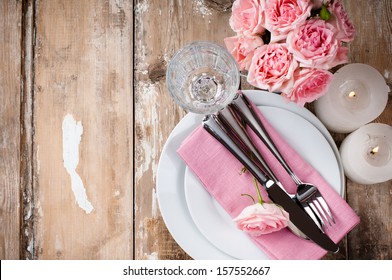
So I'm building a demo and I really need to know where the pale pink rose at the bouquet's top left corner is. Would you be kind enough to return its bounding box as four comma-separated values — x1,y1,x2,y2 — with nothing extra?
229,0,265,36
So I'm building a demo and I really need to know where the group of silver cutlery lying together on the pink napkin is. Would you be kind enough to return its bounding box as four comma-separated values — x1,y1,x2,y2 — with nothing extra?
203,93,339,252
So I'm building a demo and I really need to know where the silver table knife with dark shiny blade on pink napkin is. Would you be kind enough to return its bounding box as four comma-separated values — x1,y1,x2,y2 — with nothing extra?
203,115,339,253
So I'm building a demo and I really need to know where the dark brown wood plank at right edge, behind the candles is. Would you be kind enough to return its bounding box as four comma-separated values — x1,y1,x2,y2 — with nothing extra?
345,0,392,259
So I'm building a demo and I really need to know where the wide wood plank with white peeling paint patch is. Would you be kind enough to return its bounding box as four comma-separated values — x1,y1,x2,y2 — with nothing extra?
33,0,133,259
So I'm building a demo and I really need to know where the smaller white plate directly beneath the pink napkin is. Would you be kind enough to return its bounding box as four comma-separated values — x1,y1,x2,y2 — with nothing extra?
184,106,341,260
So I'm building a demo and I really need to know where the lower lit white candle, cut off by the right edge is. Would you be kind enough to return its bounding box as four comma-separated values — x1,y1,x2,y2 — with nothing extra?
340,123,392,184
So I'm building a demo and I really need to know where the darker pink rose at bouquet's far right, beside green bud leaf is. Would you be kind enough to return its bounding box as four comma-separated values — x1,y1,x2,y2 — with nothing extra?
330,0,355,42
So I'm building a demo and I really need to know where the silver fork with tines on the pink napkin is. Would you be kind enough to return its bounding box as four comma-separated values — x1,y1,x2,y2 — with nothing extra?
229,94,336,230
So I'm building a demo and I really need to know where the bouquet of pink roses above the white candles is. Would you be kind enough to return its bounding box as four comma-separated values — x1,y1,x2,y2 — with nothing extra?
224,0,355,106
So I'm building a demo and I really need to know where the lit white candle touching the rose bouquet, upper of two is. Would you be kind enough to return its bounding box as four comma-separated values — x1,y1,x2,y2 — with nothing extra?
315,63,389,133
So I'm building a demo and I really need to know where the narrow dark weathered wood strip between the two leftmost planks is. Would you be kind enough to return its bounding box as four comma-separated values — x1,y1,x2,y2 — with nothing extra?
20,0,35,259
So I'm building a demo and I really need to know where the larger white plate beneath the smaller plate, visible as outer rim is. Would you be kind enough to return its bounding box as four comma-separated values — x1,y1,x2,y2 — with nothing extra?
157,90,344,259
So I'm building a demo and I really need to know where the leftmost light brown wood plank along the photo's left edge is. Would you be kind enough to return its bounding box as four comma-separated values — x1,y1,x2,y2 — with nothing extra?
0,1,22,259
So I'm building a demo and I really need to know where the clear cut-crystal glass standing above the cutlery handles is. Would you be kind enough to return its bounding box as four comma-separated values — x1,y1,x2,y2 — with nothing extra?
166,42,240,115
